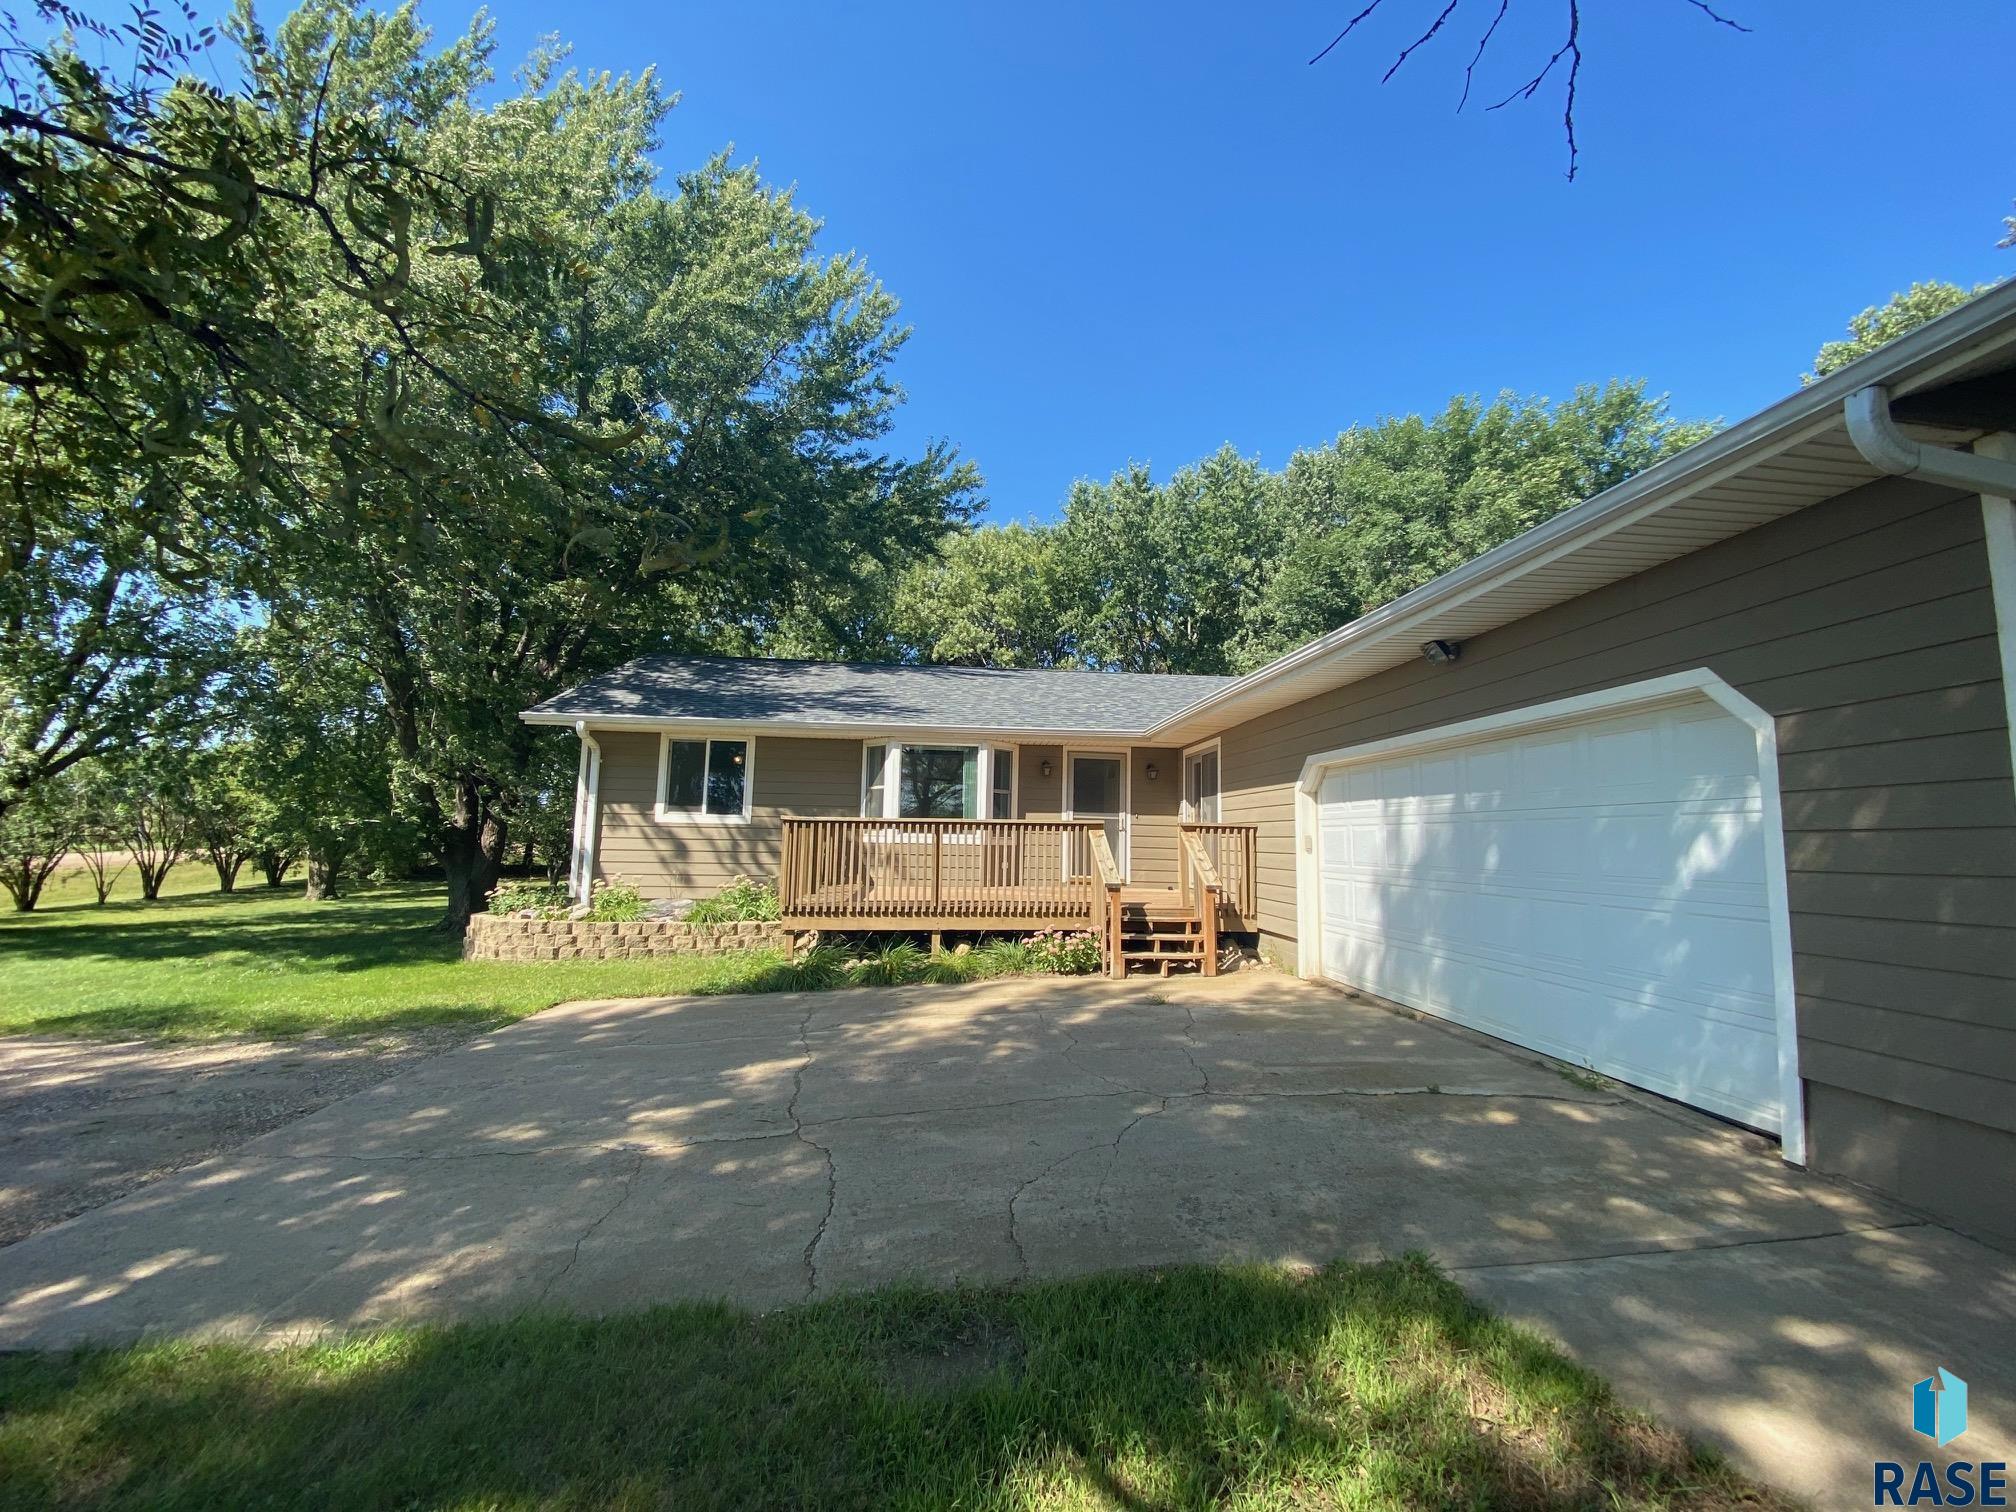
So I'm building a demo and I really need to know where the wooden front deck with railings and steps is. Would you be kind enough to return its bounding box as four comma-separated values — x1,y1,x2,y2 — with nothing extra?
778,818,1254,976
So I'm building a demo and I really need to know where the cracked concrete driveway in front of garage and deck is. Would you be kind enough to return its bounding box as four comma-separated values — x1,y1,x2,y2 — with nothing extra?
0,972,2016,1494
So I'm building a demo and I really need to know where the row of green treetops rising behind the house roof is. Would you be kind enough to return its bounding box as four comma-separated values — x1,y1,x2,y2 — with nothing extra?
861,381,1714,673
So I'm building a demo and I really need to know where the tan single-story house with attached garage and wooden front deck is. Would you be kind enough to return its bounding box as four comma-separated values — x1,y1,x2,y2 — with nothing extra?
524,284,2016,1240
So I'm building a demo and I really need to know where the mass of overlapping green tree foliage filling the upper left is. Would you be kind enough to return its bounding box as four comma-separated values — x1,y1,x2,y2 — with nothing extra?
0,0,978,921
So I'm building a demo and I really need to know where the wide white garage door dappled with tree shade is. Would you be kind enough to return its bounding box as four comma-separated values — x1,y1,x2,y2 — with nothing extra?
1316,700,1780,1131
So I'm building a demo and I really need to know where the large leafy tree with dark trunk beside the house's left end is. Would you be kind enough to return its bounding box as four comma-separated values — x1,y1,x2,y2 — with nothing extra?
272,6,972,925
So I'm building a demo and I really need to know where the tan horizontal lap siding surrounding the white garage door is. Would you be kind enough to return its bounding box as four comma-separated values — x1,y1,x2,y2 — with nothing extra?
1224,480,2016,1233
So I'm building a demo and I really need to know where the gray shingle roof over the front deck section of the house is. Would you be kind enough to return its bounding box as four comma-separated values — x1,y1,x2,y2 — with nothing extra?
526,655,1234,736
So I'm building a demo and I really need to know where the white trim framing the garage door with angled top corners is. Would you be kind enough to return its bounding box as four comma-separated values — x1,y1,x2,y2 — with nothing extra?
1294,667,1806,1165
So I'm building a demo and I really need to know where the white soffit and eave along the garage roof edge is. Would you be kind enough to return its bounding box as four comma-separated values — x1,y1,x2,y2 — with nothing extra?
1147,280,2016,746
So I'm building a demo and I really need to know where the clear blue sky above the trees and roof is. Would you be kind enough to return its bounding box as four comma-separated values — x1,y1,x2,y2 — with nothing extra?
441,0,2016,518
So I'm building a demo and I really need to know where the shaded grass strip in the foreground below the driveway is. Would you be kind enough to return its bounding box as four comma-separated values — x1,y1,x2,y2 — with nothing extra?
0,1260,1778,1508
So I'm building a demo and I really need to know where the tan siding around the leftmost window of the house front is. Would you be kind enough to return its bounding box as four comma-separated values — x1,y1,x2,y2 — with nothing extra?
595,730,861,897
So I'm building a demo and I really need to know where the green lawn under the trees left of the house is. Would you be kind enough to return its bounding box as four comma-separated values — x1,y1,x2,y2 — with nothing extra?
0,865,802,1038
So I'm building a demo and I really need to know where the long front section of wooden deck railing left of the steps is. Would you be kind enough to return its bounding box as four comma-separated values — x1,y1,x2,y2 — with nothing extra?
778,818,1107,929
